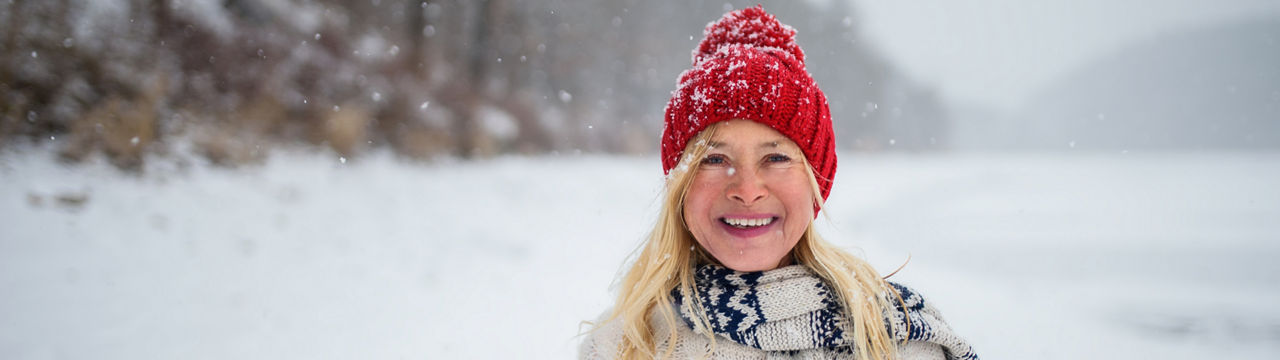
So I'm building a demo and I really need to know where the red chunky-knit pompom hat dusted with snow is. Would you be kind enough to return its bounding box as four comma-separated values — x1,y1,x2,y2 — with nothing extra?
662,5,836,200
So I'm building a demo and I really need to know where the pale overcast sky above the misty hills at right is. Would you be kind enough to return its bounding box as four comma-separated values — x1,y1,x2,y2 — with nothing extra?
850,0,1280,110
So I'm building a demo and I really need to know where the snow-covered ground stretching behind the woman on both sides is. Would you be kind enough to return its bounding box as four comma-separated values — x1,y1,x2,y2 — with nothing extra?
0,150,1280,359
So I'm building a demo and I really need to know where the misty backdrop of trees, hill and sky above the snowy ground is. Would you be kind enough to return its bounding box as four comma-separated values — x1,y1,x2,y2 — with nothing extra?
0,0,1280,163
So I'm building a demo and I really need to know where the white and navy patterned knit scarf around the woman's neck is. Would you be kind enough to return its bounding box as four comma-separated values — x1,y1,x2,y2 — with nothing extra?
672,264,978,360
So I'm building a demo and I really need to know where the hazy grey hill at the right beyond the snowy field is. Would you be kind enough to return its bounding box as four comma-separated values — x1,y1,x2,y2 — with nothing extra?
1001,15,1280,150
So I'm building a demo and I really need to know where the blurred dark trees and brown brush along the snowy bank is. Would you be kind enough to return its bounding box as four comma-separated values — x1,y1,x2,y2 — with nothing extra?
0,0,946,169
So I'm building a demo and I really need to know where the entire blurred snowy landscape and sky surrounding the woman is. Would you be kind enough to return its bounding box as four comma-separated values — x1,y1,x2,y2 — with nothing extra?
0,0,1280,359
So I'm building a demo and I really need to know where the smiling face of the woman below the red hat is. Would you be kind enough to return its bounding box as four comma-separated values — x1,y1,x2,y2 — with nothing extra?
684,119,814,272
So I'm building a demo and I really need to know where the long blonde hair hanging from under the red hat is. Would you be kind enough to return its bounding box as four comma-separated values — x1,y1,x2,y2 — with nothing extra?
604,123,897,359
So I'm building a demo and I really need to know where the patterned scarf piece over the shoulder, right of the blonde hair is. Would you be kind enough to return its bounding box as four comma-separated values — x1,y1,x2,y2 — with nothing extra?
884,282,978,360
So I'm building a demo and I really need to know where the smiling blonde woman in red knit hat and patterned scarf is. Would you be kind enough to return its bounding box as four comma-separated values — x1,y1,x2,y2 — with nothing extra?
580,6,977,359
